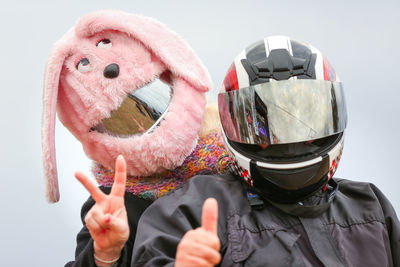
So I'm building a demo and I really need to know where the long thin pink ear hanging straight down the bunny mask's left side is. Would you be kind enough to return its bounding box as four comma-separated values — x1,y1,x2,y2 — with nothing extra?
42,29,73,202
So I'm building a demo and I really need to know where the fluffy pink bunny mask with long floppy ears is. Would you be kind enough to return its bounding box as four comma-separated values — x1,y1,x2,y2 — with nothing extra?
42,11,212,202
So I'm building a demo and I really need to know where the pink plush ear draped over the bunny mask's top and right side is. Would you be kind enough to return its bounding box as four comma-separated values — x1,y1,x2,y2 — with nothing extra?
76,10,212,91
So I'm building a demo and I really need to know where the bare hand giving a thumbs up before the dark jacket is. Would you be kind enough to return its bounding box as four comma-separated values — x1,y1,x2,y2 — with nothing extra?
175,198,221,267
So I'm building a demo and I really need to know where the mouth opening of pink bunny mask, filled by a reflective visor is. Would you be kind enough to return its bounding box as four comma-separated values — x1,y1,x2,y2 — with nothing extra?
89,74,173,138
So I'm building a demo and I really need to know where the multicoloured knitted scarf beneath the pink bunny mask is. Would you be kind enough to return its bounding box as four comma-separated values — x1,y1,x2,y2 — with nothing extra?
93,132,228,200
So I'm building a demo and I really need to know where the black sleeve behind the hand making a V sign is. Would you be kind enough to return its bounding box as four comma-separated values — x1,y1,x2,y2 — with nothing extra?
65,187,151,267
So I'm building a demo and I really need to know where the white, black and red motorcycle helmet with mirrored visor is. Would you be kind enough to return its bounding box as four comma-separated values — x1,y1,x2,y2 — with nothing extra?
218,36,347,203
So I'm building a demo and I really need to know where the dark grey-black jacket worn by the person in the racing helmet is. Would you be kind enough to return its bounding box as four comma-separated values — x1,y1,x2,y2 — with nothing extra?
132,174,400,267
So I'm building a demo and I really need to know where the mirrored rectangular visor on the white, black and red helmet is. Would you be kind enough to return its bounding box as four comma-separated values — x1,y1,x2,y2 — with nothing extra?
218,79,347,144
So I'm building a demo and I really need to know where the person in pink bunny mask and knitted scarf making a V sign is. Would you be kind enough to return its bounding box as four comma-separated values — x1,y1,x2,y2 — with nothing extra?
42,10,226,267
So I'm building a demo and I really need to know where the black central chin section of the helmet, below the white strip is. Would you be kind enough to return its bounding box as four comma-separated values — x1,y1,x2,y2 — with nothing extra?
250,155,329,203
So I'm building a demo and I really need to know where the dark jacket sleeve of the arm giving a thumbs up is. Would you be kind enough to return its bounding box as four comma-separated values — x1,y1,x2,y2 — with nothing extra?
131,176,236,267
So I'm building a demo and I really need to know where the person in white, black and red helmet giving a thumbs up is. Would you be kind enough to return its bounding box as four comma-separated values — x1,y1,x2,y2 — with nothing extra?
132,36,400,267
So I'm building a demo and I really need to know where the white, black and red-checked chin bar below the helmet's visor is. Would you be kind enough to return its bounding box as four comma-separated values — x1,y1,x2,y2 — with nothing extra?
223,129,344,204
